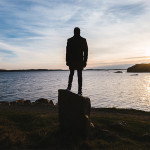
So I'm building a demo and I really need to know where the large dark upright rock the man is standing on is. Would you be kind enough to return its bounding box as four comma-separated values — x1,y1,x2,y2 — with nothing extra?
58,89,91,136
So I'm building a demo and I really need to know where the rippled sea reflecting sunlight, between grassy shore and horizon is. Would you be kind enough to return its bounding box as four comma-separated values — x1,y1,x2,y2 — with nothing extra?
0,70,150,111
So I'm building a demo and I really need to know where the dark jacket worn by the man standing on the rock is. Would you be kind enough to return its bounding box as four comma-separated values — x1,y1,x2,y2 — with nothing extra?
66,36,88,65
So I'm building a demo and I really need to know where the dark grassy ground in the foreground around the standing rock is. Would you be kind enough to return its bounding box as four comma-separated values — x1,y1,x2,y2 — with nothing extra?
0,105,150,150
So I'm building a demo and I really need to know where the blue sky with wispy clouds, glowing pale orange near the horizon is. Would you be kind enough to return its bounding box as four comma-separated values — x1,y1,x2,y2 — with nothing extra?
0,0,150,69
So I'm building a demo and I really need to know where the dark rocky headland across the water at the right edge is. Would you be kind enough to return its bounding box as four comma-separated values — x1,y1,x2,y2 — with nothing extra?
127,63,150,72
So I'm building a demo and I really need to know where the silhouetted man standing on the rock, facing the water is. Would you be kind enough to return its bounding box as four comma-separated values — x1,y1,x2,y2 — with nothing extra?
66,27,88,95
